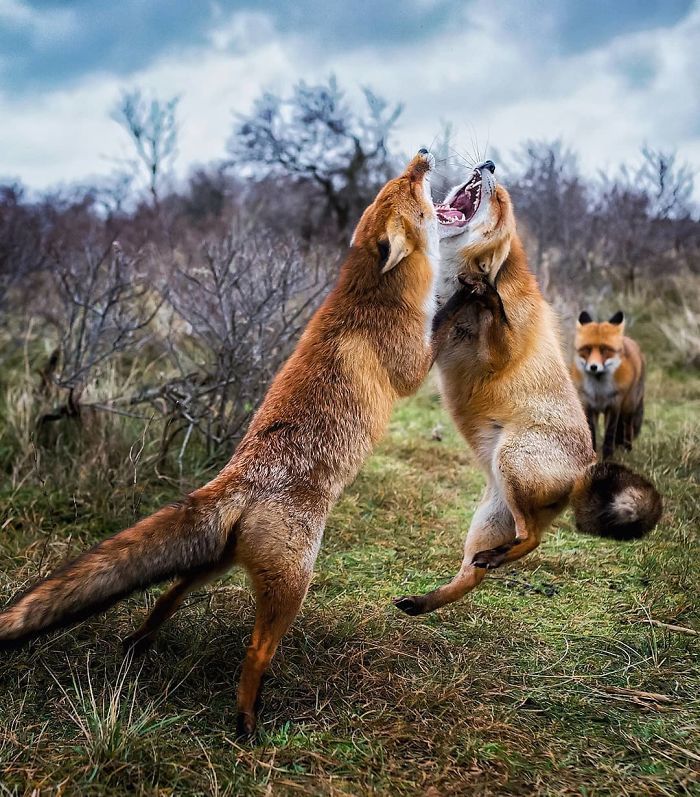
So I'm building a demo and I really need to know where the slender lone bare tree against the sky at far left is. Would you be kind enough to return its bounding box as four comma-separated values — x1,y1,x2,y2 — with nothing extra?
112,89,180,209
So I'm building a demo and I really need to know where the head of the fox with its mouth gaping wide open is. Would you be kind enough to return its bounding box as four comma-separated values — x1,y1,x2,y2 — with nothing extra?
436,161,515,284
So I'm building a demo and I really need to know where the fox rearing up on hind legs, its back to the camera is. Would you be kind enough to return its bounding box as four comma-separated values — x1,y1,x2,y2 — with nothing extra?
0,148,439,737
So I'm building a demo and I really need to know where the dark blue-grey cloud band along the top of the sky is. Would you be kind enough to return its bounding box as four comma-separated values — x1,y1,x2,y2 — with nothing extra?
0,0,692,96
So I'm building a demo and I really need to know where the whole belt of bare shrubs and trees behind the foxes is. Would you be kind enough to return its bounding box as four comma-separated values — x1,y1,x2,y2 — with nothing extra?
0,78,700,482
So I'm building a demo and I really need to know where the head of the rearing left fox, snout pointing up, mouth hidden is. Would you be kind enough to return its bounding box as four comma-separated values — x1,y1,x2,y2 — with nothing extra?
351,149,438,274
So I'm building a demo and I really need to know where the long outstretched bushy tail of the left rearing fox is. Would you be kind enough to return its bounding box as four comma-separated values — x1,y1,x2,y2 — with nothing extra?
0,493,240,649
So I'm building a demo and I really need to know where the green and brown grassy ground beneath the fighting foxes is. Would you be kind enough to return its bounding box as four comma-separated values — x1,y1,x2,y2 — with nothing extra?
0,370,700,797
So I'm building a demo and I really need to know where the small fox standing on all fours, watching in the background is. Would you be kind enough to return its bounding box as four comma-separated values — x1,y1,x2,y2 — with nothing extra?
571,310,646,459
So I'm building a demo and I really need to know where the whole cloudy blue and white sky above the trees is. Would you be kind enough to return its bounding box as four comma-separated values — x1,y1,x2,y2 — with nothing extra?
0,0,700,196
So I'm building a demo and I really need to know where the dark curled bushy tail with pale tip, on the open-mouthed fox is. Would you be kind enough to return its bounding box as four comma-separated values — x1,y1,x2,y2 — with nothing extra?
571,462,663,540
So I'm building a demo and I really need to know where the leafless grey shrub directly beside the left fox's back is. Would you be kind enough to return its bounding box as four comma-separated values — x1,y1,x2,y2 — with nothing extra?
130,219,329,464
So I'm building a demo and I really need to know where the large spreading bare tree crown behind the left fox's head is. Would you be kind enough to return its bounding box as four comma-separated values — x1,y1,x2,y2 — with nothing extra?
229,77,402,231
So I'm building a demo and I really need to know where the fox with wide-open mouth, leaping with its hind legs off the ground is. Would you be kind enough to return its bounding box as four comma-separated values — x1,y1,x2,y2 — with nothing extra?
394,161,662,615
